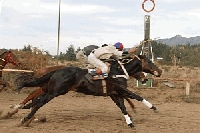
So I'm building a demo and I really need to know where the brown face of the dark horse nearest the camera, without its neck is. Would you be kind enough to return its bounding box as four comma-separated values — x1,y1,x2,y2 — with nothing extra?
138,55,162,77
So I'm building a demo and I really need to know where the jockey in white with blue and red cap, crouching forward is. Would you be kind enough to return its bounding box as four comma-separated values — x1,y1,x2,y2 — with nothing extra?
88,42,137,77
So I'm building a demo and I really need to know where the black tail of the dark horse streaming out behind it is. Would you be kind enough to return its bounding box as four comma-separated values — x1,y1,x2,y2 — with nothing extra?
16,70,56,91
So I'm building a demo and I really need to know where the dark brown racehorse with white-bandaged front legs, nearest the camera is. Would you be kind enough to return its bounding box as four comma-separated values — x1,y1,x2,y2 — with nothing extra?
18,55,162,127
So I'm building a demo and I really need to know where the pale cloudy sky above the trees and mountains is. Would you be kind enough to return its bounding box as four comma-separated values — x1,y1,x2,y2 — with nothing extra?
0,0,200,55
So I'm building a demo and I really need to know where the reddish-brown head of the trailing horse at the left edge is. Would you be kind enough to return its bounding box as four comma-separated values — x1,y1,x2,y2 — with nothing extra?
0,51,20,66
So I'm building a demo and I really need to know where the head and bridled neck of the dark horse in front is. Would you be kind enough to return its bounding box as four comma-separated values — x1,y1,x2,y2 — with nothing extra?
109,55,162,79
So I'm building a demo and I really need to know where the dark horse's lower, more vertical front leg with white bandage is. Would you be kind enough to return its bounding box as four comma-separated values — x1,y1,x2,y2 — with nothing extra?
110,95,134,128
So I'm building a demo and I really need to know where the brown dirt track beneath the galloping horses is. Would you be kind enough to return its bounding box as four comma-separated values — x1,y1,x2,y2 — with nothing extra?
0,84,200,133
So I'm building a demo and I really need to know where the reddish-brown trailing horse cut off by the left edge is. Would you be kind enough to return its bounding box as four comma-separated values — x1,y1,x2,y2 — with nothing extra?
0,51,20,92
